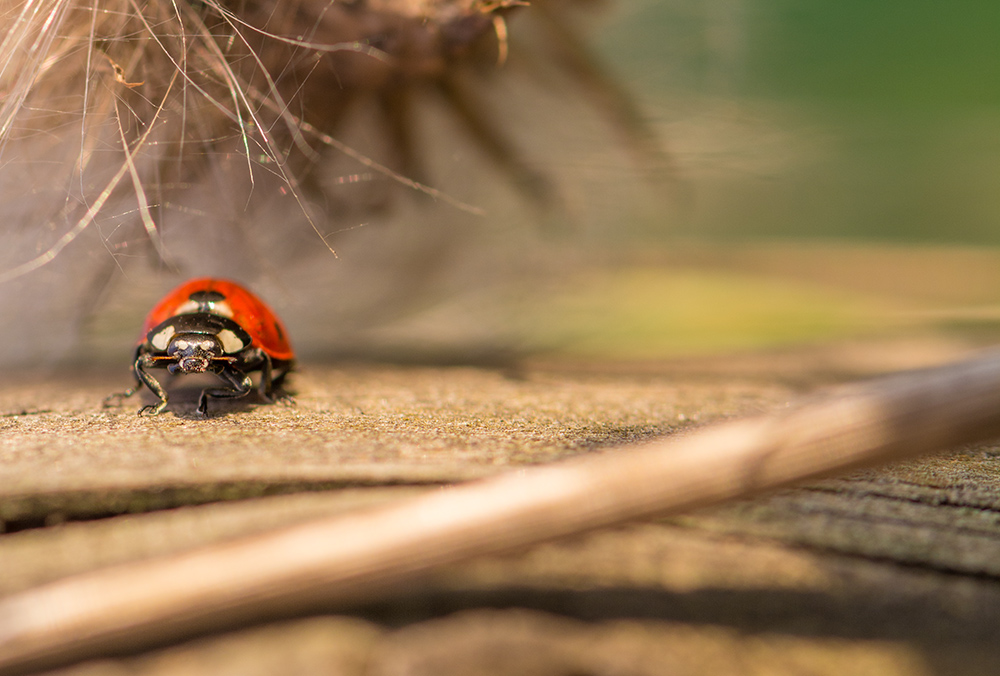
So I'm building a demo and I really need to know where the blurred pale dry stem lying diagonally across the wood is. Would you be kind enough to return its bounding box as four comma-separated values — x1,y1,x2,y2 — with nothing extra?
0,353,1000,673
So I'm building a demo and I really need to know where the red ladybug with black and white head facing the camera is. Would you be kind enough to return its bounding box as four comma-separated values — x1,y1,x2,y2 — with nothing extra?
109,277,295,416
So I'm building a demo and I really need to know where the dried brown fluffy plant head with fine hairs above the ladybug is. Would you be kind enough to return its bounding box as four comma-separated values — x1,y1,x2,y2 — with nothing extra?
0,0,662,362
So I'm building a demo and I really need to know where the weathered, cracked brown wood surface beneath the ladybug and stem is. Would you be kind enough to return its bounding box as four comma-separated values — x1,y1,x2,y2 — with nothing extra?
0,344,1000,674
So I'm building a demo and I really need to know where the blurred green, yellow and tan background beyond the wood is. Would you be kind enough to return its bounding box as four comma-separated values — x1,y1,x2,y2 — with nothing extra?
74,0,1000,368
